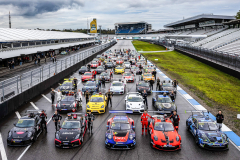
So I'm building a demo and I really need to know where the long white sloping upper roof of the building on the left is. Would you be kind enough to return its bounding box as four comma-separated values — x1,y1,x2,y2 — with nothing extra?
0,28,92,43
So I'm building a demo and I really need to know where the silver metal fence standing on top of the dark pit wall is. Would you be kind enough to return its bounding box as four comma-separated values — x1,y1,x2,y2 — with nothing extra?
0,41,115,103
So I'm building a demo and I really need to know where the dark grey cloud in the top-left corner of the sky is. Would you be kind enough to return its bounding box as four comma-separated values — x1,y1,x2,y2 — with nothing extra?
0,0,84,17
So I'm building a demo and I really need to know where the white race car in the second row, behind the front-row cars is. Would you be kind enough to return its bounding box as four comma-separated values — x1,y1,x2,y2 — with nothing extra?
125,92,144,113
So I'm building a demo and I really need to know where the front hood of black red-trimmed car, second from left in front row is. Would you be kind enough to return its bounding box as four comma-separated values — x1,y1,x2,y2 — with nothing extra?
59,129,81,141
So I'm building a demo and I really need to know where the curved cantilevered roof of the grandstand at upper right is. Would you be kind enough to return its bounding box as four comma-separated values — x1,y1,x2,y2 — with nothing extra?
164,14,235,27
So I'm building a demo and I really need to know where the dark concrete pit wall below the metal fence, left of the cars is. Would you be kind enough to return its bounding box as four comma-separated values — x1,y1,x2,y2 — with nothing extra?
0,44,114,119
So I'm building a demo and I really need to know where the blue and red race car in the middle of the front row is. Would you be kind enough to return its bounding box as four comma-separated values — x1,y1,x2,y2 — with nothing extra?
105,111,136,149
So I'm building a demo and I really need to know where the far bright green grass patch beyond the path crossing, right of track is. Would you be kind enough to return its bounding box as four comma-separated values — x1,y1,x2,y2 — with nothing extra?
132,41,165,51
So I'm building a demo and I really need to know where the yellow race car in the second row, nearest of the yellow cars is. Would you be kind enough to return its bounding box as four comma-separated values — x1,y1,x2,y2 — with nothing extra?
86,94,107,114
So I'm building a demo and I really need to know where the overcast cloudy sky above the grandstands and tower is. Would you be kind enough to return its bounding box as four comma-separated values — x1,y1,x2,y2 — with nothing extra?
0,0,240,29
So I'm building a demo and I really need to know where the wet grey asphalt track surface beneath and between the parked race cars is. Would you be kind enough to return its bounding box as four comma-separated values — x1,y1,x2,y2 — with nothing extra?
1,40,240,160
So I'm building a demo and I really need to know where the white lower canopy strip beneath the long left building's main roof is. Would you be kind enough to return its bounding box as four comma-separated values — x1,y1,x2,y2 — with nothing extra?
0,40,94,59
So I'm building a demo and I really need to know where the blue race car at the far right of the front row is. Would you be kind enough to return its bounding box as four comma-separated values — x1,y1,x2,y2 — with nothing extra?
186,111,229,150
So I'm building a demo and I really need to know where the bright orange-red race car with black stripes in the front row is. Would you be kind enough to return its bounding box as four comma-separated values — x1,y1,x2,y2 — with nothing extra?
149,115,181,151
